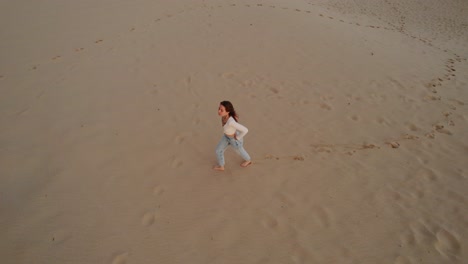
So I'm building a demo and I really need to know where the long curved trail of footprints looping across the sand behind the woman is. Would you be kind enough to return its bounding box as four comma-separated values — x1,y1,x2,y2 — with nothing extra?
0,0,467,157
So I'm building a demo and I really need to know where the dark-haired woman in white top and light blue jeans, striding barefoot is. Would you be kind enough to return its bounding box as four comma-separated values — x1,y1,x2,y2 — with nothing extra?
213,101,252,171
